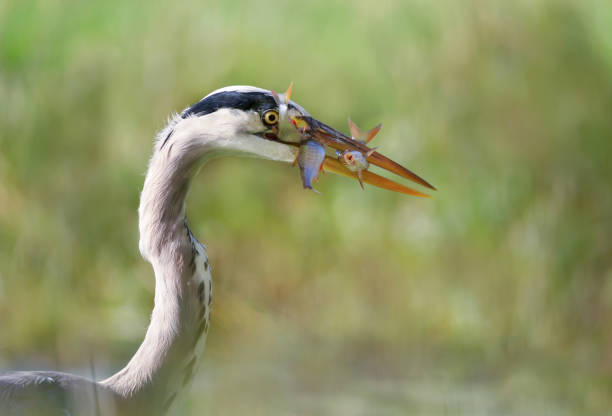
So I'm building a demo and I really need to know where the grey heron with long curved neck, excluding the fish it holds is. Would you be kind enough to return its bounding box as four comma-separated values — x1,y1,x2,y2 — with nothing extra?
0,86,434,416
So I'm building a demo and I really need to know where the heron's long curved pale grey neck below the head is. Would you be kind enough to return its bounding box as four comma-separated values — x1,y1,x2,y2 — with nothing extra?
102,118,214,411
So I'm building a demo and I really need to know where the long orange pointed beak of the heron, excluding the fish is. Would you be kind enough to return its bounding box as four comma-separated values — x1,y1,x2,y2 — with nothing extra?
290,115,436,197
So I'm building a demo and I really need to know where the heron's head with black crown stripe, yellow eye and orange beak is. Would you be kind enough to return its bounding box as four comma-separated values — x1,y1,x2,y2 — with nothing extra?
177,86,435,196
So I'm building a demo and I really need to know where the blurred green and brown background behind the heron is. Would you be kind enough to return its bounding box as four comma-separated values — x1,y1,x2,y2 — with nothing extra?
0,0,612,415
